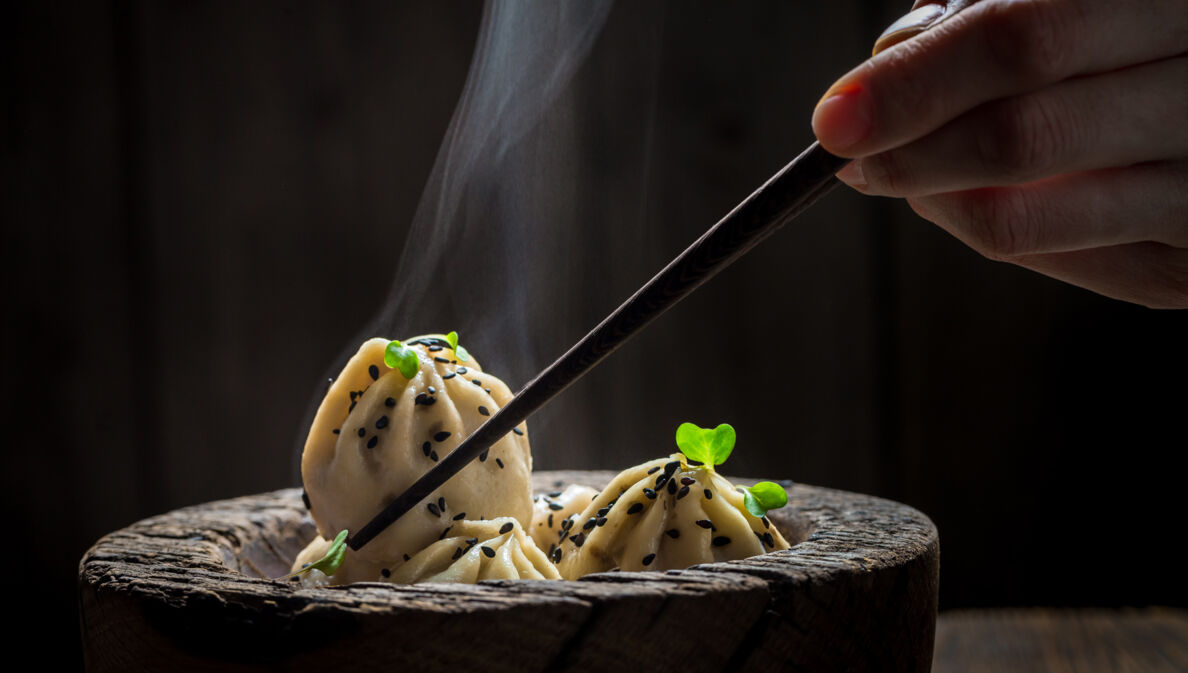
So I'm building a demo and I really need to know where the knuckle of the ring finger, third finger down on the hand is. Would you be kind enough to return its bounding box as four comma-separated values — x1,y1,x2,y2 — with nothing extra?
965,189,1036,262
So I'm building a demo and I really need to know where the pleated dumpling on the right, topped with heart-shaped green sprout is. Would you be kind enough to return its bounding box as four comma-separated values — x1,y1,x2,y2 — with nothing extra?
552,453,789,579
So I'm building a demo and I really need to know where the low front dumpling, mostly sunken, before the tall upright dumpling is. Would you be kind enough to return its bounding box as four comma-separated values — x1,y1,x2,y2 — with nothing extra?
387,516,561,584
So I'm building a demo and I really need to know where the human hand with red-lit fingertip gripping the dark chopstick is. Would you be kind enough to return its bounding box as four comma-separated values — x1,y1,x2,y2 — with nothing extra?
813,0,1188,308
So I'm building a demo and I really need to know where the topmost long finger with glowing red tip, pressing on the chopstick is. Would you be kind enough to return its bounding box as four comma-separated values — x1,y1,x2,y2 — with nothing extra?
813,0,1188,157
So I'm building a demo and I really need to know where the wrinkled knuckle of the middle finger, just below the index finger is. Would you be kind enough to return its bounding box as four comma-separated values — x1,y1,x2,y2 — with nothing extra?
977,95,1073,182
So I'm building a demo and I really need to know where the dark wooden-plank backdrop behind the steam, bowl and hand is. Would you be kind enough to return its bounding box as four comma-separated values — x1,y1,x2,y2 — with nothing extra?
0,1,1188,665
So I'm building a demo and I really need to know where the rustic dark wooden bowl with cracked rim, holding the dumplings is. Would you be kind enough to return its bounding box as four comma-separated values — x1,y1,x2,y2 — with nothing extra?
78,472,940,673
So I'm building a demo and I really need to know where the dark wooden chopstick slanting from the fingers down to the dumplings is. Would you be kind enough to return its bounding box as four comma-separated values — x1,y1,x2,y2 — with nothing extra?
347,143,849,551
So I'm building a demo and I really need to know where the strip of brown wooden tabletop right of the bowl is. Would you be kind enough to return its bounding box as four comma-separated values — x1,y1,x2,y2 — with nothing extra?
933,608,1188,673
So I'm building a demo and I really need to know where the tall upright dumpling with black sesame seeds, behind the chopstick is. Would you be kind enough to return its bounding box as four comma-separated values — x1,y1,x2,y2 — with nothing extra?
302,337,532,563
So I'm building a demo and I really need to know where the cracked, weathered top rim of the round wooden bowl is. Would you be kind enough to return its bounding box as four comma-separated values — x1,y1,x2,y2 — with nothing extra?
80,472,936,611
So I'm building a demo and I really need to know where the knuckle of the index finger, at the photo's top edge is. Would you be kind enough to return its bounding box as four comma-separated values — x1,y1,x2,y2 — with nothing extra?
981,0,1076,83
